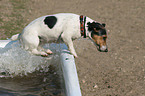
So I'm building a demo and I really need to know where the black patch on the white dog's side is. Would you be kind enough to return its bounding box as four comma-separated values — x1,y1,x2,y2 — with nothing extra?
44,16,57,29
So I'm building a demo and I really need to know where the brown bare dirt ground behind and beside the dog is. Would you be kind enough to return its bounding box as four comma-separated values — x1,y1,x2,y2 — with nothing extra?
0,0,145,96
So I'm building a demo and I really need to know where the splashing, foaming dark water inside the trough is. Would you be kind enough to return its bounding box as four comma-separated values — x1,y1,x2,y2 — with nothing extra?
0,42,64,96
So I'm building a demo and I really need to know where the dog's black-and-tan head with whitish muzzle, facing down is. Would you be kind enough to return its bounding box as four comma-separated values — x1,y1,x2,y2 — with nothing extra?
87,22,108,52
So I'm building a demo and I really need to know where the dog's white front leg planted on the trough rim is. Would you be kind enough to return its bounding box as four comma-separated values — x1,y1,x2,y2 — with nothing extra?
63,38,78,58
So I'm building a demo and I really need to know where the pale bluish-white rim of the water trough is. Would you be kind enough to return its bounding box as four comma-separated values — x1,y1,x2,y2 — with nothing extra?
0,40,82,96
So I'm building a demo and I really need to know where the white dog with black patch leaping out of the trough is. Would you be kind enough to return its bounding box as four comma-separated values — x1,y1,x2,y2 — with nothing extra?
11,13,108,57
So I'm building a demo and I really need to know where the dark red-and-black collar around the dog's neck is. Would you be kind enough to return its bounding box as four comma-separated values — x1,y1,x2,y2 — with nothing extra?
80,15,86,38
